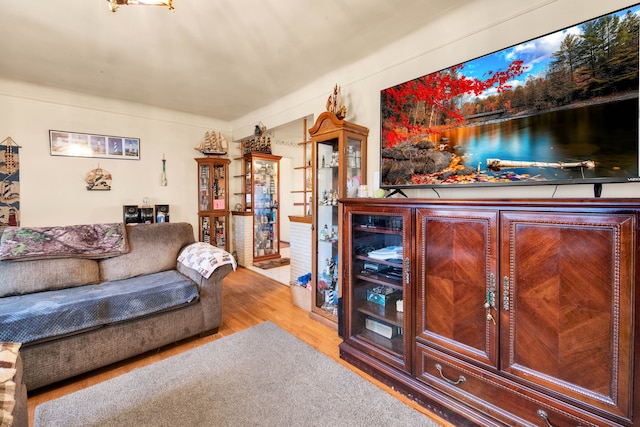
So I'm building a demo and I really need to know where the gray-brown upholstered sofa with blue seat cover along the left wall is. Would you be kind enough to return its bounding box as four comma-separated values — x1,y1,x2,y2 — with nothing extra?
0,223,235,390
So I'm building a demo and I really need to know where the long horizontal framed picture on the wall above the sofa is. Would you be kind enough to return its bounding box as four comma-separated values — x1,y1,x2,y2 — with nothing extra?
49,130,140,160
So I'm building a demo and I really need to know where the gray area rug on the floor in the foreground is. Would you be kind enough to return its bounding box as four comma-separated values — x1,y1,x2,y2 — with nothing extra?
34,322,439,427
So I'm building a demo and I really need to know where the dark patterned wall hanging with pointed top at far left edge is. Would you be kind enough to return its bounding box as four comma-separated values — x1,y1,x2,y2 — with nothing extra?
0,136,20,232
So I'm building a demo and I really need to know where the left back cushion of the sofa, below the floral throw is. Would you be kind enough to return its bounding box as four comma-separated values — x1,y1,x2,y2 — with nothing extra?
0,258,100,297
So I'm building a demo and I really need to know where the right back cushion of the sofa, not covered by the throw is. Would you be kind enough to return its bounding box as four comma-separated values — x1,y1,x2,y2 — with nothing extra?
99,222,195,281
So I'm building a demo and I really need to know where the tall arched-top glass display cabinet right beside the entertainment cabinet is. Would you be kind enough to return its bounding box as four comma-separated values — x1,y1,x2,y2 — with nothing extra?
309,112,369,333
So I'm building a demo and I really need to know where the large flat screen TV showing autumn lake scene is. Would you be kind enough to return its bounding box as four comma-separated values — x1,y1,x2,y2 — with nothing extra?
380,4,640,189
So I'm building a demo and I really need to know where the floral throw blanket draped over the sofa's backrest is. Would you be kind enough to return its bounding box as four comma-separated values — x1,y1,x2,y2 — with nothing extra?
0,223,129,261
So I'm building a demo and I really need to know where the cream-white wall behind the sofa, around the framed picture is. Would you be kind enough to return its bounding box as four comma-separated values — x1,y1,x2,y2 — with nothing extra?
0,80,231,232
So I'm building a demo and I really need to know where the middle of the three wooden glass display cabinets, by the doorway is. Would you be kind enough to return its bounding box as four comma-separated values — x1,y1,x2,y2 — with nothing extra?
243,153,281,262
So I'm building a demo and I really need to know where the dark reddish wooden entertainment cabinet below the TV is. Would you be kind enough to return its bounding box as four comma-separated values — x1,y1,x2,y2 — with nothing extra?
340,198,640,427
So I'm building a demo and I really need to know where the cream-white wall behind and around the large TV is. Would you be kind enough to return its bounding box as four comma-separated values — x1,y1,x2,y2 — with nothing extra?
232,0,640,198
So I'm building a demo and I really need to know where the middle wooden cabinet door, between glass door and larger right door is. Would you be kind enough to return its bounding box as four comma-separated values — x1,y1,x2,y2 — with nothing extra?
416,209,499,367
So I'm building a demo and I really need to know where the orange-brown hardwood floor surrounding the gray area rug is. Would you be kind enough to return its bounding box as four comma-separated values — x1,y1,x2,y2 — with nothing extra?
28,267,451,426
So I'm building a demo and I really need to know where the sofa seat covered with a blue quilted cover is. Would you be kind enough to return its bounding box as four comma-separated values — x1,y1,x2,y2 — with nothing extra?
0,270,198,343
